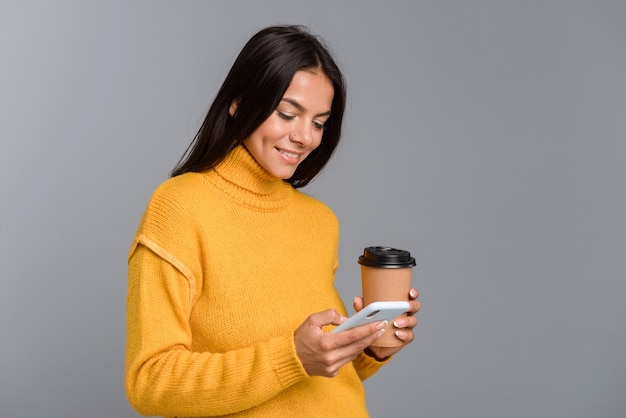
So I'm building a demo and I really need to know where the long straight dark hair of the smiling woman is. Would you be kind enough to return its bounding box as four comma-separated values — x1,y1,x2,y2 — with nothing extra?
171,26,346,188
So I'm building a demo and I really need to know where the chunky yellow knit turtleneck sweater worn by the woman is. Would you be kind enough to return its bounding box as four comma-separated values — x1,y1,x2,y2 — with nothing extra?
126,146,382,417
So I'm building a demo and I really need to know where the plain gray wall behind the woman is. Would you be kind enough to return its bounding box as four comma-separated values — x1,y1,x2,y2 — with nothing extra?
0,0,626,418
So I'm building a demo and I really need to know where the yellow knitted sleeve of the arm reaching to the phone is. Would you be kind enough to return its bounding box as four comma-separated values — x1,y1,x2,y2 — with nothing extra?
126,243,308,416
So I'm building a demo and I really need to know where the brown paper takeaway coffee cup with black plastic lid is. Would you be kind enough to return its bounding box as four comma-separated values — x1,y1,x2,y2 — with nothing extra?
359,247,415,347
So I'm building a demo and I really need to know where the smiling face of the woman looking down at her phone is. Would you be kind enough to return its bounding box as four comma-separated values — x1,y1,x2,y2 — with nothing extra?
240,71,334,180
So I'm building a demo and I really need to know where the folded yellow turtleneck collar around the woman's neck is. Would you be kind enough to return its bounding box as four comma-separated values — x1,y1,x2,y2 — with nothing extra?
206,145,294,210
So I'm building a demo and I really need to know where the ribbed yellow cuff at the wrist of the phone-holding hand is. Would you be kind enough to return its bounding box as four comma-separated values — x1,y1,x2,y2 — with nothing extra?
269,335,309,388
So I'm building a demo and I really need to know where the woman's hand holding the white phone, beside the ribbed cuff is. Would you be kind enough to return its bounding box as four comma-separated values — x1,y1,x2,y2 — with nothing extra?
294,309,386,377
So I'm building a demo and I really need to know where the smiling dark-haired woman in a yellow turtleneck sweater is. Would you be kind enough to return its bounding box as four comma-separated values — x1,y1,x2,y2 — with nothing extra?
126,26,419,417
